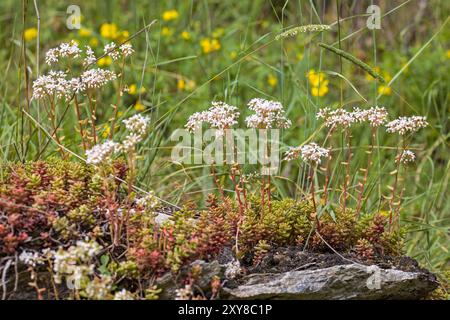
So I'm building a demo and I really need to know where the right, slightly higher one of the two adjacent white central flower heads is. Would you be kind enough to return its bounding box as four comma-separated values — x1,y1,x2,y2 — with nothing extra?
245,98,291,129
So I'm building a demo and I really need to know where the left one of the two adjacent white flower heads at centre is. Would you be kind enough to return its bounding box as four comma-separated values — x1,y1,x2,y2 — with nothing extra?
185,101,239,132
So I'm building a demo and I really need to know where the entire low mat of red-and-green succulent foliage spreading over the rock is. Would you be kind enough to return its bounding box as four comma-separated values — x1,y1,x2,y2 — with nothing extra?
0,159,403,302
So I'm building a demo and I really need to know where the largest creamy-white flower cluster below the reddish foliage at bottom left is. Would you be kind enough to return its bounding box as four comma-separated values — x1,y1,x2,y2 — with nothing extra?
53,241,102,286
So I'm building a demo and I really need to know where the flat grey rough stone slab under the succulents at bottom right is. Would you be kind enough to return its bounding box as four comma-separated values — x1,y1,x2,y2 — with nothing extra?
224,264,438,300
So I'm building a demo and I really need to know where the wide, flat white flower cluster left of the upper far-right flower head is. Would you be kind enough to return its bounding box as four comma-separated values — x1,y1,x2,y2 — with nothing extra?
316,106,388,128
